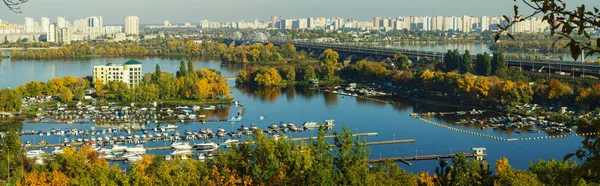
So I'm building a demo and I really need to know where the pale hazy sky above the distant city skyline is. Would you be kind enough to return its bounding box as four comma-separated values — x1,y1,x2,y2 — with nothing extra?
0,0,600,24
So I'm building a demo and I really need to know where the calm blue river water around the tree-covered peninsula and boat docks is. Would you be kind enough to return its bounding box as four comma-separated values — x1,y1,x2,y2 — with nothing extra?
0,58,582,172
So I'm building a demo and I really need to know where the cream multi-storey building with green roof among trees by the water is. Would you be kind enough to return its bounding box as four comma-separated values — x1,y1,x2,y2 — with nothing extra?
92,60,143,87
